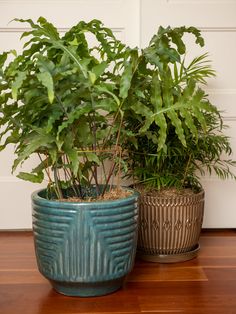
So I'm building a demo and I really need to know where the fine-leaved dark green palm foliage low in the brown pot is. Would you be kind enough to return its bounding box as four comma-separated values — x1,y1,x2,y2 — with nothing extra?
129,116,236,192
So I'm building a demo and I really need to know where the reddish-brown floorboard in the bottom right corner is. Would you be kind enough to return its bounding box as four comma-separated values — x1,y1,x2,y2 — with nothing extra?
136,282,236,314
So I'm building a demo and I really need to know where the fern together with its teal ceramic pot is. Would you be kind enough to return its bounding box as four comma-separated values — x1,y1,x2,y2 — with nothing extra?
0,17,138,296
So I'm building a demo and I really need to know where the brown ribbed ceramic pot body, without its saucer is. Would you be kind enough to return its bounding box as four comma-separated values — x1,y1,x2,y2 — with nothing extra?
138,191,204,255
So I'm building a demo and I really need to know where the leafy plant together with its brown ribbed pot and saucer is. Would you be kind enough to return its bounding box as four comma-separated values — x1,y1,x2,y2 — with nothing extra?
123,27,235,262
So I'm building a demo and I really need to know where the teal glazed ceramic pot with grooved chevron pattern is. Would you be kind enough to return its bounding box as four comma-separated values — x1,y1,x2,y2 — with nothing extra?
32,186,139,297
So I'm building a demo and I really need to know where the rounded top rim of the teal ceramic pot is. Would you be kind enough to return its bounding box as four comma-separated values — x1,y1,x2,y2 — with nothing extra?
31,186,140,209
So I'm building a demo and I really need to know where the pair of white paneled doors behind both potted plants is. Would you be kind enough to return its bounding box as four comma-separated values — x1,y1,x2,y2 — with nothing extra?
0,0,236,229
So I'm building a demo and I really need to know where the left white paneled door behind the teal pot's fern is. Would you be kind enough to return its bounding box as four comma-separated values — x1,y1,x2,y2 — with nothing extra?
0,0,140,229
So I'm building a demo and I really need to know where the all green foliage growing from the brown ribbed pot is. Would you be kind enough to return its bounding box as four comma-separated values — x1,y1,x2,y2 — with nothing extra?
123,27,236,191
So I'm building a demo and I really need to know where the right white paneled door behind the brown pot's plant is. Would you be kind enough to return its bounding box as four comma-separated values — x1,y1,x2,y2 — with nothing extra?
140,0,236,228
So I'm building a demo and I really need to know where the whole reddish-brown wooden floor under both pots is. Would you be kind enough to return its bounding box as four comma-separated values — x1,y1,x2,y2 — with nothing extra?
0,230,236,314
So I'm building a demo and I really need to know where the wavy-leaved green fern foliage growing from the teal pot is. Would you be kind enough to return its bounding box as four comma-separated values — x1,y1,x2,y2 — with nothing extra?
0,17,135,199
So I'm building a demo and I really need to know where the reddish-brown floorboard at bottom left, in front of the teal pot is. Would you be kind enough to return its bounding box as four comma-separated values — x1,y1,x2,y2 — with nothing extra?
0,284,140,314
